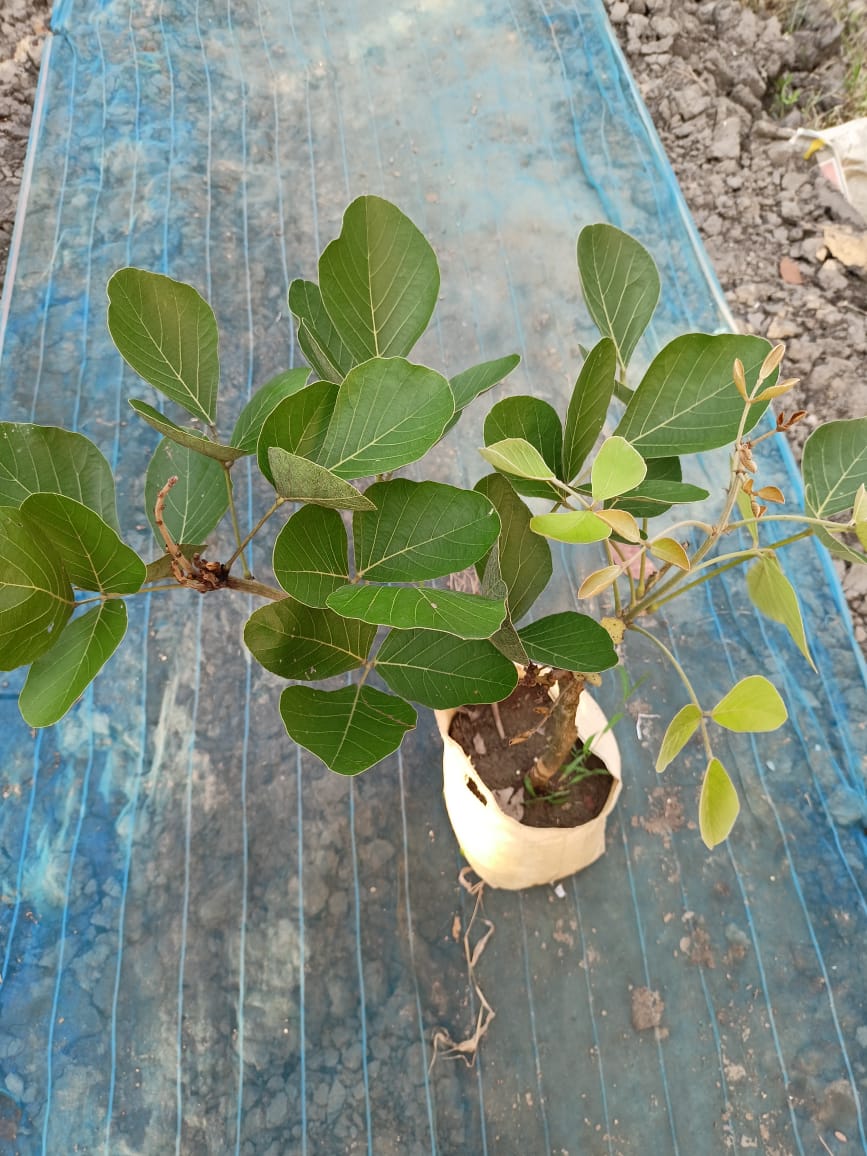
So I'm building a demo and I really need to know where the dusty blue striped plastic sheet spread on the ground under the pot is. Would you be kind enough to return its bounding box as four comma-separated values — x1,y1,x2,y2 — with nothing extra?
0,0,867,1156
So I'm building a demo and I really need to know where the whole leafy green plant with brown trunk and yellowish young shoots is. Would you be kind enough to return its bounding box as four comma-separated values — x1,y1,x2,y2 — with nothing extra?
0,197,867,864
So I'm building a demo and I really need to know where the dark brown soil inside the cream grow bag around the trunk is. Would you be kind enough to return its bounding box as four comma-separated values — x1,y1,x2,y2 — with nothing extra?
450,683,614,827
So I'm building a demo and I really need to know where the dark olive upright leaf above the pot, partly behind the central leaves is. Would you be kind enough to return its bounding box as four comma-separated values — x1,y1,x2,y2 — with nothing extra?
475,474,554,622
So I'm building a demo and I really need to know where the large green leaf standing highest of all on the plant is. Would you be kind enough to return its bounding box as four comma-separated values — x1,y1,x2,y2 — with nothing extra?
319,197,439,362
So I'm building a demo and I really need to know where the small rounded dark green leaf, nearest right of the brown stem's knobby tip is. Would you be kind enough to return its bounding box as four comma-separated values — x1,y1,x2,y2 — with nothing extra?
273,506,349,606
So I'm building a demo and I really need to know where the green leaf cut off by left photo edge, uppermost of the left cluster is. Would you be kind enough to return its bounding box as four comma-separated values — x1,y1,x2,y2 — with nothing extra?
0,422,118,529
